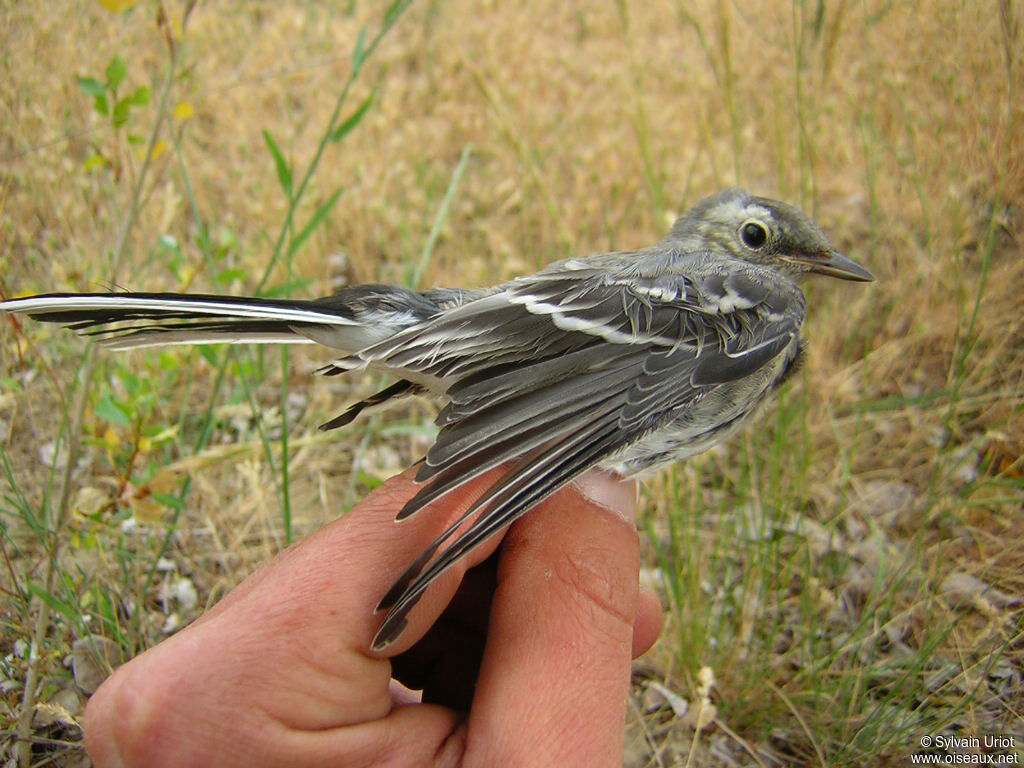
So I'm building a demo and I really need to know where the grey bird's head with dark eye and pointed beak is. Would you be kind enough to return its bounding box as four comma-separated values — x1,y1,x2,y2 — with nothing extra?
668,189,874,282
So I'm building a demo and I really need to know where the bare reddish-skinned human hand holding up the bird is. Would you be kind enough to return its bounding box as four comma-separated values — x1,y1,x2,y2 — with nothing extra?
84,470,662,768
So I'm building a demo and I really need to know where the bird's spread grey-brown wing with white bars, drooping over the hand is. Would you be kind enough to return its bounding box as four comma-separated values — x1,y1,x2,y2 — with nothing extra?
358,260,803,648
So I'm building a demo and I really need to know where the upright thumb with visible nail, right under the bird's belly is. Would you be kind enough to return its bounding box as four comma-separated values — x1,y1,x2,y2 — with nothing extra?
466,471,640,766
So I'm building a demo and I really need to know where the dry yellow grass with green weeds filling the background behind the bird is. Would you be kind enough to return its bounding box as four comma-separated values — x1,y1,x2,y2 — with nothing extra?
0,0,1024,766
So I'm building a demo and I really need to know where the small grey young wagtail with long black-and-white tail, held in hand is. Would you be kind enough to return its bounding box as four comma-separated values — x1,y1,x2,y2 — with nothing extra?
0,189,872,649
